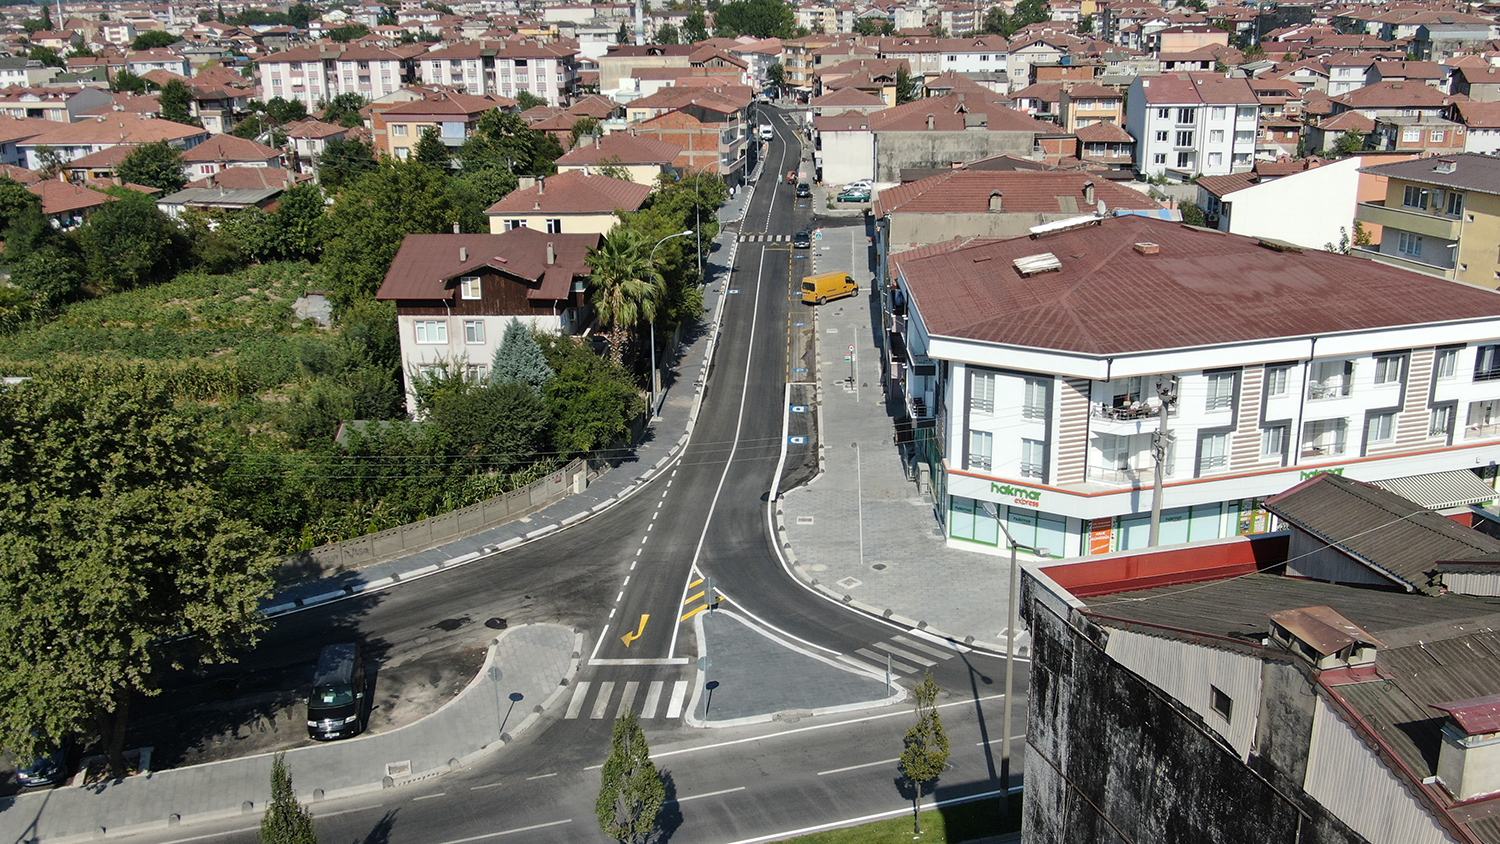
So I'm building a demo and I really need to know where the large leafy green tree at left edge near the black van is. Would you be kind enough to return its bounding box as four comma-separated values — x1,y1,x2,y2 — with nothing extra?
0,369,273,777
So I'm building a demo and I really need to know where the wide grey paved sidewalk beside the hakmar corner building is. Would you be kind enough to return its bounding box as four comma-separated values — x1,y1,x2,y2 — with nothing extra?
774,220,1032,655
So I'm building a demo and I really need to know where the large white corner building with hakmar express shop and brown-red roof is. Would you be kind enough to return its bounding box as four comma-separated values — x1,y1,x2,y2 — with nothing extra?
890,216,1500,558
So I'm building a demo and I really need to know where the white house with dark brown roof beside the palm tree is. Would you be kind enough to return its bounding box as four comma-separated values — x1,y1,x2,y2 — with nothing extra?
375,228,600,414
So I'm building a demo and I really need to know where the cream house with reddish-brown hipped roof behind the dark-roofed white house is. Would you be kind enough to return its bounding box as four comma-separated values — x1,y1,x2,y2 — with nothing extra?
485,171,651,234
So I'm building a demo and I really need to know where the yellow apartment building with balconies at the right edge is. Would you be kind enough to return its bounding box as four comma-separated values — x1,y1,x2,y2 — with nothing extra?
1355,153,1500,288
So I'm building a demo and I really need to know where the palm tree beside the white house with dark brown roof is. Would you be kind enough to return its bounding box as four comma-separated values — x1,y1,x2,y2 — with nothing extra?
588,226,666,363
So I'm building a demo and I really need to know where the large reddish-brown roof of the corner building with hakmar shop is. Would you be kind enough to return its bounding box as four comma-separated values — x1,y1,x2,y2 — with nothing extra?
905,216,1500,355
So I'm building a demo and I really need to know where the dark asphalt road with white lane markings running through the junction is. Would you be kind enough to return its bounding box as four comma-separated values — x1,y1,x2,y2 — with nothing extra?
108,107,1026,844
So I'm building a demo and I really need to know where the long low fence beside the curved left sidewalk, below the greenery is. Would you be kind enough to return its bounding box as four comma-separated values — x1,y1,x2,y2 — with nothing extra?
278,459,591,586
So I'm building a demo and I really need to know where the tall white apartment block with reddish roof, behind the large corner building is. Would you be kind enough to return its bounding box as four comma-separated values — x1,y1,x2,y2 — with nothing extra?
1125,72,1260,178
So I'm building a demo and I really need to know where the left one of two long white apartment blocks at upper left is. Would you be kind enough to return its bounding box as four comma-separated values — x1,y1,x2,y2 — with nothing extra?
255,43,414,111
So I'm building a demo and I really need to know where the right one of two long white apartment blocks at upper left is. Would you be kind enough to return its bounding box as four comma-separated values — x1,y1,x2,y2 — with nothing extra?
419,40,578,105
